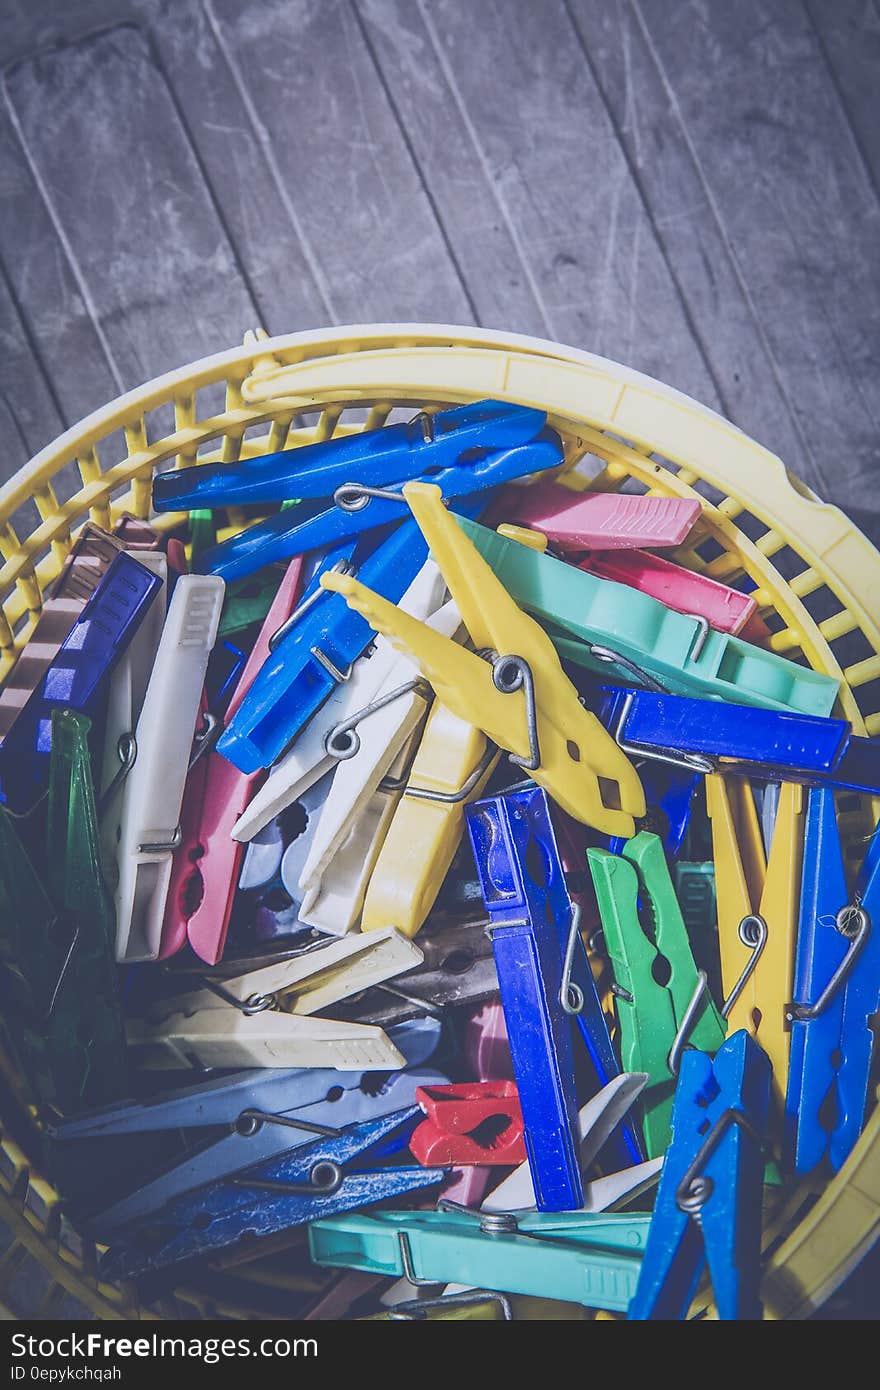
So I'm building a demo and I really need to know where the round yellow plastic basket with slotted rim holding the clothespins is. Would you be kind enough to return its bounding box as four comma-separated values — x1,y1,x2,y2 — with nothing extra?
0,324,880,1318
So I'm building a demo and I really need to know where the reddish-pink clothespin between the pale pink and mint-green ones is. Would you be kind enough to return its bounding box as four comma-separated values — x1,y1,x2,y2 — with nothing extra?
577,550,767,642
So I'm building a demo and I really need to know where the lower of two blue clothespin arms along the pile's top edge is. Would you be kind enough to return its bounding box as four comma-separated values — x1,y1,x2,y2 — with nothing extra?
199,430,563,582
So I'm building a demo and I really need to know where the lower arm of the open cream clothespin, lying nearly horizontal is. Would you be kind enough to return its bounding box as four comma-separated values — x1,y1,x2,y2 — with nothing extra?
127,999,406,1072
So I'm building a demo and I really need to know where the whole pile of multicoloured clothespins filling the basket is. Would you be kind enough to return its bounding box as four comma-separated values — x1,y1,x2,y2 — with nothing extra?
0,400,880,1319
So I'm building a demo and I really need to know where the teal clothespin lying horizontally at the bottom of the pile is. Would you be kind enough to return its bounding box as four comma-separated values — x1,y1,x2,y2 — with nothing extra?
309,1211,651,1312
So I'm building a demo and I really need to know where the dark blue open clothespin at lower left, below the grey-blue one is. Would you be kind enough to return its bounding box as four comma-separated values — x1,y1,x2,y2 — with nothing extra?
101,1105,446,1279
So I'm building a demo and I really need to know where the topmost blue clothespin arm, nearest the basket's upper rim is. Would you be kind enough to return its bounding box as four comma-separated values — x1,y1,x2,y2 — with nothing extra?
153,400,546,512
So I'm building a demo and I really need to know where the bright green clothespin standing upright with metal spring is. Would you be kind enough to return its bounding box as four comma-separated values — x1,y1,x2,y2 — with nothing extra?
587,831,724,1158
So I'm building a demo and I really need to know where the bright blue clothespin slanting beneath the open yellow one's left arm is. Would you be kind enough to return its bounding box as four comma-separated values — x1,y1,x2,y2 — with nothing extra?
217,520,428,773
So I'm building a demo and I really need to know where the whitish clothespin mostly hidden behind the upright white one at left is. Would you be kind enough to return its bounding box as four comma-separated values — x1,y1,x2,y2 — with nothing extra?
99,550,168,892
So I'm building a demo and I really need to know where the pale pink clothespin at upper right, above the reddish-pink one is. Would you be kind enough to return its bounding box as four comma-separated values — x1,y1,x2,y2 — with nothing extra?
491,482,701,550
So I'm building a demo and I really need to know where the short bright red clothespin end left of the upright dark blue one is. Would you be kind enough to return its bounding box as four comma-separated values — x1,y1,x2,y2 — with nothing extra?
410,1081,525,1168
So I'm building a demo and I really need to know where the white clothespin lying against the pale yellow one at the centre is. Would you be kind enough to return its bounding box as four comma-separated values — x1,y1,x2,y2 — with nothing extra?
293,600,462,931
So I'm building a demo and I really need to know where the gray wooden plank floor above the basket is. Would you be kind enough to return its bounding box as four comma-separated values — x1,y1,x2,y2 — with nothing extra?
0,0,880,535
